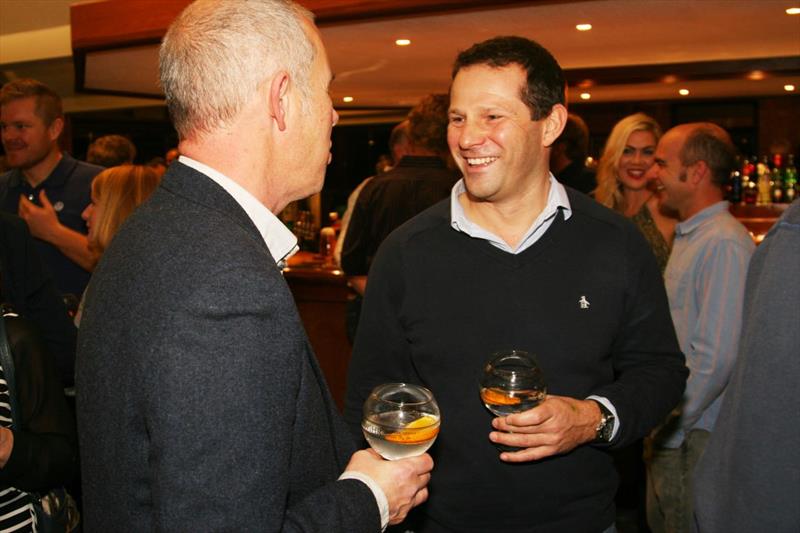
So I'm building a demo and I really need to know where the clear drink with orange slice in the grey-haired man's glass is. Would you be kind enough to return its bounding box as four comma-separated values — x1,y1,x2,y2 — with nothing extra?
361,410,439,460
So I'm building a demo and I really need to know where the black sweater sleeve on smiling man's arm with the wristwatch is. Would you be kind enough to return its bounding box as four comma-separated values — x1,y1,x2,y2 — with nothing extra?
593,225,689,448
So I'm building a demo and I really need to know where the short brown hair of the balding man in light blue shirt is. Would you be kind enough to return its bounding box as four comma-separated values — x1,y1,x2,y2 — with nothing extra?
679,123,736,187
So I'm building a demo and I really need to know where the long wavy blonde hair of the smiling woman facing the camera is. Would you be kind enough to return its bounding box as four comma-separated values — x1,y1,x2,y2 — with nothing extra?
594,113,661,212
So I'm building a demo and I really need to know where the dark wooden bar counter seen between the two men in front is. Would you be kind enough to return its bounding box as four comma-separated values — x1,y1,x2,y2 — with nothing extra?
283,251,353,410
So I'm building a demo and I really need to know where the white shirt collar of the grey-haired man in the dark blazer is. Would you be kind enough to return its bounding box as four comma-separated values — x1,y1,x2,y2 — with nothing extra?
178,155,299,266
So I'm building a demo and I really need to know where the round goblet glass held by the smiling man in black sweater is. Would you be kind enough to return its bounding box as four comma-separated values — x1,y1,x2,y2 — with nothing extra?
480,350,547,451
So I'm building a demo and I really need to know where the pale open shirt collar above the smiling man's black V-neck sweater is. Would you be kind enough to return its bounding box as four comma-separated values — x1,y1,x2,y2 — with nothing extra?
450,173,572,254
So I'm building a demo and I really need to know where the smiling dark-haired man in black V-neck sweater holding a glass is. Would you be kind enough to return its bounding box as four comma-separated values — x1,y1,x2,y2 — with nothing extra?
345,37,687,533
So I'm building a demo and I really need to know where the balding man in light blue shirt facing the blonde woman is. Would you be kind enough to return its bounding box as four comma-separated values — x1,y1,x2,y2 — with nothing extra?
647,123,755,533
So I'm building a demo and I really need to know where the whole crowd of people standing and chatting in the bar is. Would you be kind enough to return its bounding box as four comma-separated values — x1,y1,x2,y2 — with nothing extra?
0,0,800,533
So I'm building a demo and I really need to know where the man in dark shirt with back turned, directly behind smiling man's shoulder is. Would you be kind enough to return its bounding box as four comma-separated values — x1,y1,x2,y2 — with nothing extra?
342,95,458,294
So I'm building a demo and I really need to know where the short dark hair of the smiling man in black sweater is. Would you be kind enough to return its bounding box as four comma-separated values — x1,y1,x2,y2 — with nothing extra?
453,36,566,120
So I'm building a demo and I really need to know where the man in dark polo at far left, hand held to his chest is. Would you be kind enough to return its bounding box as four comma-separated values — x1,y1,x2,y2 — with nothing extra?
0,79,102,296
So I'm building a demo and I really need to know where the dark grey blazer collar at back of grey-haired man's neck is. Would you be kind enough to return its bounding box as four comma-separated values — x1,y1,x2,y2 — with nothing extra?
160,161,266,247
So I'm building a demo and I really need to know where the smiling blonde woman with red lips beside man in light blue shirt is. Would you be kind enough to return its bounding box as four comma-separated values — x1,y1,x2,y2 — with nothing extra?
595,113,677,274
